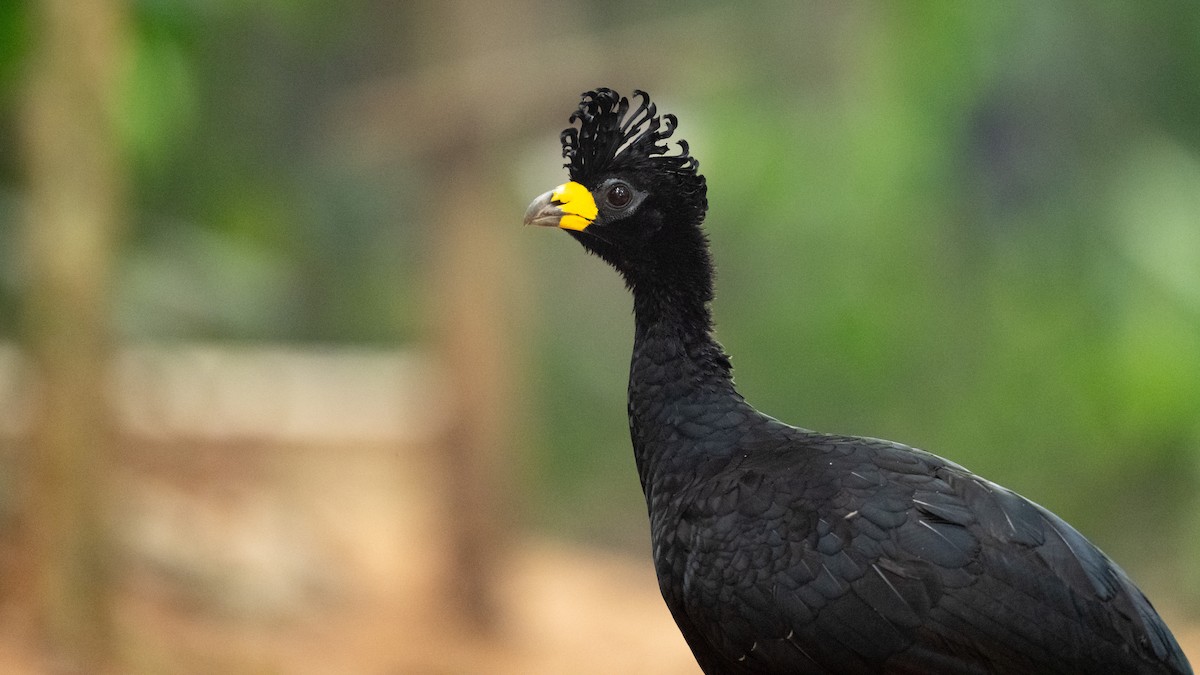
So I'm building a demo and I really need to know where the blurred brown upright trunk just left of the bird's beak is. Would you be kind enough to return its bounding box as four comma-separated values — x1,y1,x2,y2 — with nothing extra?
432,147,515,632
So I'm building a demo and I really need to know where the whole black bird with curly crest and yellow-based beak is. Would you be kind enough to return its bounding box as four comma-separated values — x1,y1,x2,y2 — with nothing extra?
524,89,1192,675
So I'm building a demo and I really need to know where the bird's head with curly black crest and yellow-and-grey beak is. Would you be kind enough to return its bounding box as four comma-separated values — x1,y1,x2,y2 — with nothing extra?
524,89,710,294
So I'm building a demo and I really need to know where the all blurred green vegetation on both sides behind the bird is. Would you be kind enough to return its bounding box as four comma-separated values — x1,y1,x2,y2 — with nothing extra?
0,0,1200,596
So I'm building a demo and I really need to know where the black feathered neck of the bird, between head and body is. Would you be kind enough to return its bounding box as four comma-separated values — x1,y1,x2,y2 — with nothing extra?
629,277,749,494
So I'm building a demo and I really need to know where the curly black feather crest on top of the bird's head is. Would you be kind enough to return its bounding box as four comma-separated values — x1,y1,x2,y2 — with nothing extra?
562,88,702,183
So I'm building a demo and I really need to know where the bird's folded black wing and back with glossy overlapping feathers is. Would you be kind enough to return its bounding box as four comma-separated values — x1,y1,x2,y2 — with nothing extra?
660,430,1189,674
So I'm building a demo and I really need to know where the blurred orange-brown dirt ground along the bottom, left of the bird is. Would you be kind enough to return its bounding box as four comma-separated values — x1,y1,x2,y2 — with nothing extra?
0,542,698,675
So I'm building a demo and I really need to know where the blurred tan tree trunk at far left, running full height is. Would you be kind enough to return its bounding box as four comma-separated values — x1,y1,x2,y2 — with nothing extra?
18,0,127,673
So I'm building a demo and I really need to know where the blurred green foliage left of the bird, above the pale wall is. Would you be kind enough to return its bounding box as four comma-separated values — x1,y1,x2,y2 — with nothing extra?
0,0,420,342
